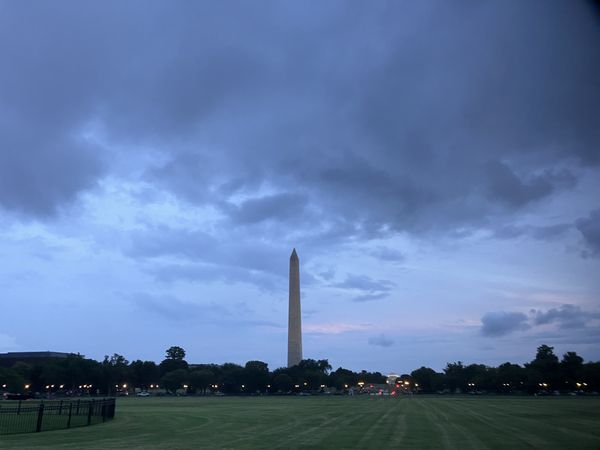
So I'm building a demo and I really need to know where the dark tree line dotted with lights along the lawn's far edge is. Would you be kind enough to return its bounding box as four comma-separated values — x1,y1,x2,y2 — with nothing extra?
0,345,600,395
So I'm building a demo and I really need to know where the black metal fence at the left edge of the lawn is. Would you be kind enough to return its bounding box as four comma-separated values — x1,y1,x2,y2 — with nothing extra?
0,398,115,435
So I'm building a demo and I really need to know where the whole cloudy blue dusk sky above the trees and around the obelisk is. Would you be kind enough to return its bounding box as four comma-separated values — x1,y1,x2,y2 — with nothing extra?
0,0,600,372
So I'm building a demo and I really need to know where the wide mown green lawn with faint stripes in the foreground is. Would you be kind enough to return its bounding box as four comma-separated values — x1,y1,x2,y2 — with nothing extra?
0,396,600,450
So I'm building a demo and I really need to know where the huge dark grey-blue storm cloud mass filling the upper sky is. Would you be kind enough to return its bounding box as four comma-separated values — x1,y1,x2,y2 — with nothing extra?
0,1,600,243
